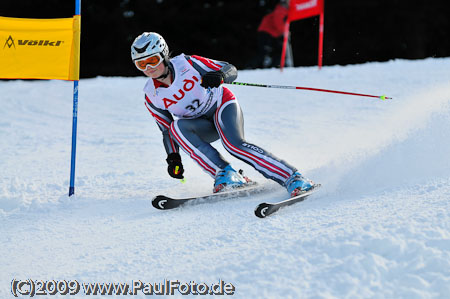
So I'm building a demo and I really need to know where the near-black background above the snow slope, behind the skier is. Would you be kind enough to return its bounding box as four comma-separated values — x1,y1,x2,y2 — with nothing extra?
0,0,450,78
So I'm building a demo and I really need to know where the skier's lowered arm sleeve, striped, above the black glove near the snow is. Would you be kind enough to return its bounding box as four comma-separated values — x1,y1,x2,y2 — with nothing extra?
145,96,179,155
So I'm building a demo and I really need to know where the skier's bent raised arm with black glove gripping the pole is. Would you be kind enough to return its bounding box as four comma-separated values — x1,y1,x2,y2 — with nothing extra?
186,55,237,87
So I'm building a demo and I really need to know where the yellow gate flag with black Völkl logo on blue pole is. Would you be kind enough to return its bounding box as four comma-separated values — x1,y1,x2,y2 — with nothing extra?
0,15,81,80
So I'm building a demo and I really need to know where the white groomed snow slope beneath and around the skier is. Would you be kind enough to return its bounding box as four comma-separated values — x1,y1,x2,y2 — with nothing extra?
0,58,450,298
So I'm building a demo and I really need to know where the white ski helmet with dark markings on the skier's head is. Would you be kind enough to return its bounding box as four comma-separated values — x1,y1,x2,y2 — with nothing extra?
131,32,169,61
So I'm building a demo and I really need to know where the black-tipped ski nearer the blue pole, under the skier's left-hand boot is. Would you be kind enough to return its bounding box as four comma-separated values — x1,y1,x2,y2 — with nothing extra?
152,182,267,210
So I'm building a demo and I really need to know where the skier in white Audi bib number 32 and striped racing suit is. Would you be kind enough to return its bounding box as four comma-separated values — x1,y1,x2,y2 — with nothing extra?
131,32,313,196
